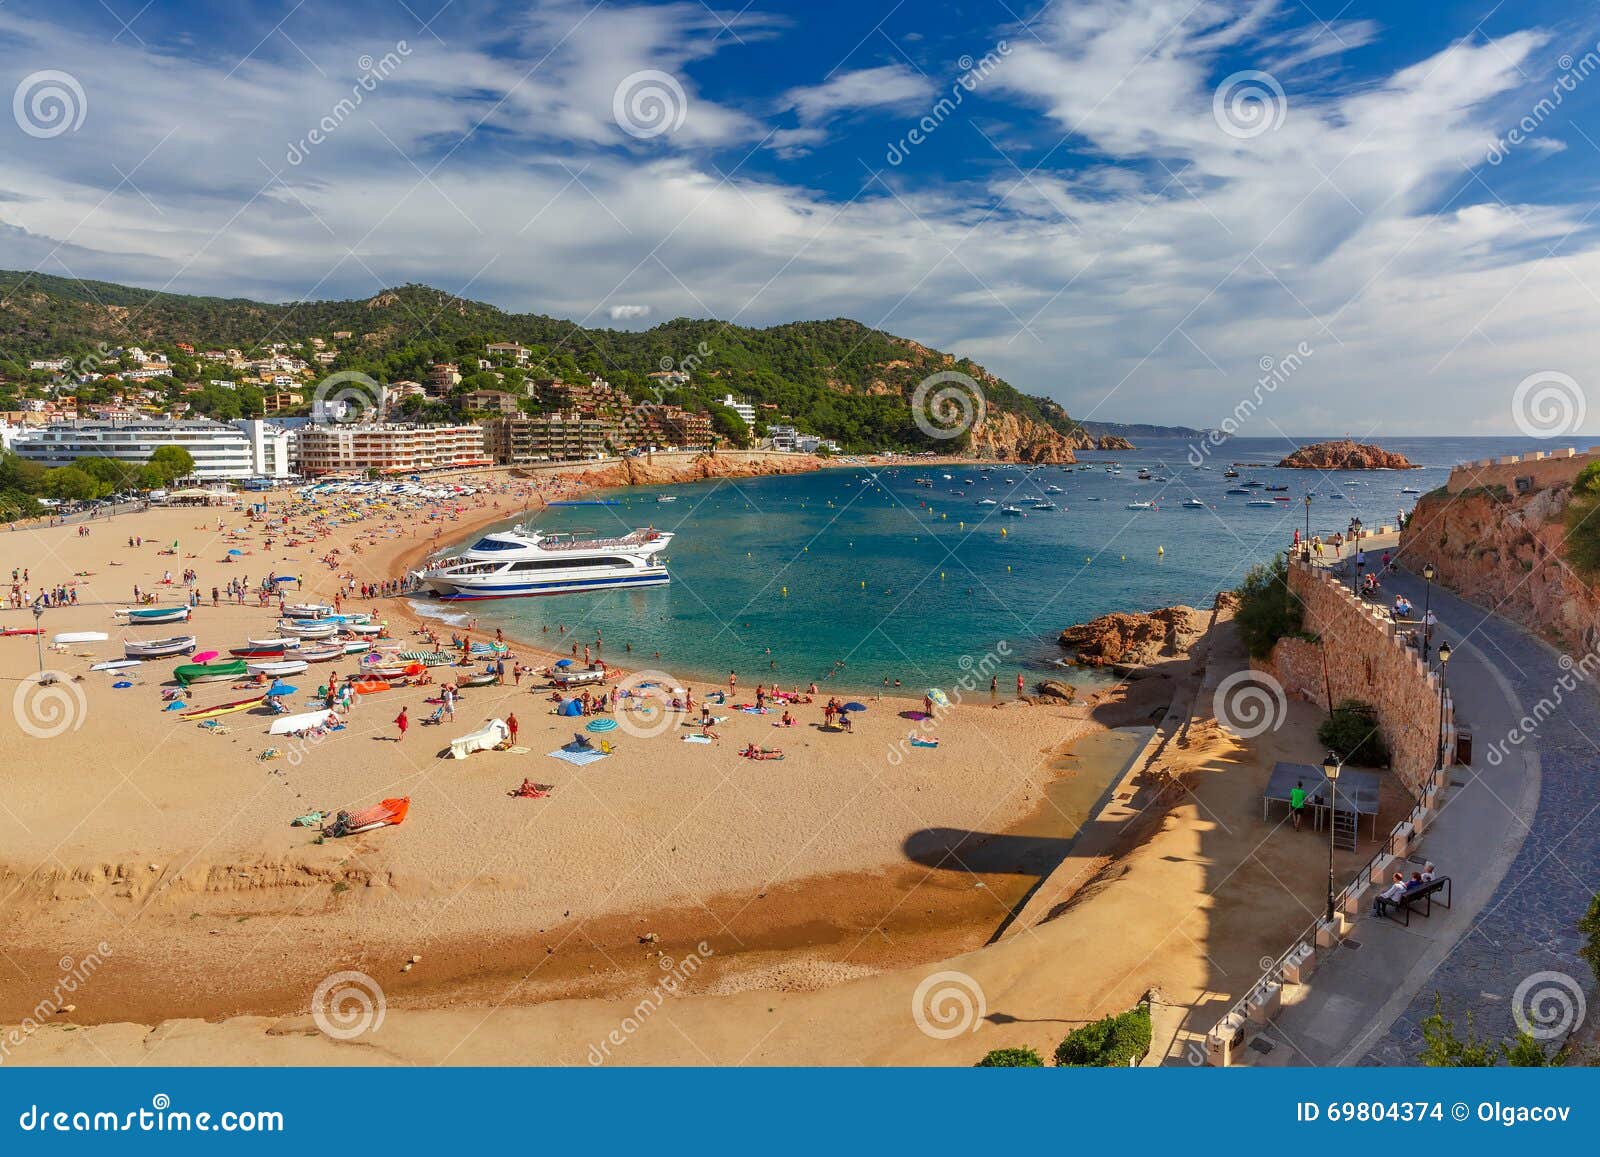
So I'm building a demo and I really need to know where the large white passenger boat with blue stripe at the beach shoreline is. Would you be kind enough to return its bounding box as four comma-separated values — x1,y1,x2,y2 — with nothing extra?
416,526,672,600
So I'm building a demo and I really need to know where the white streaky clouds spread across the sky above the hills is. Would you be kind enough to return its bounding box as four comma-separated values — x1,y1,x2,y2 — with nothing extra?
0,0,1600,435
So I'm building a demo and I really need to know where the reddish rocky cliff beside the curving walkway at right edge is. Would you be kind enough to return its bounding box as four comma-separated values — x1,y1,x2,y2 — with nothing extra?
1400,483,1600,655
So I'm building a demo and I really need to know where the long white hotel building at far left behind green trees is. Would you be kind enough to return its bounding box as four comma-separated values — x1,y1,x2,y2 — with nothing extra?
11,419,293,482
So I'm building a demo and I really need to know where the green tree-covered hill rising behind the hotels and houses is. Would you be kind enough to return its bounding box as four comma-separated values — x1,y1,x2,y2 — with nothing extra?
0,272,1086,459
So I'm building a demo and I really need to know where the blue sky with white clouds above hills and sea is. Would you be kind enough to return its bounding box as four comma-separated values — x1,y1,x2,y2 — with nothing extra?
0,0,1600,437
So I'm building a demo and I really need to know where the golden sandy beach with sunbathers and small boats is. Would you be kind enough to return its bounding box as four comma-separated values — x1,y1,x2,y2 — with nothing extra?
0,467,1395,1064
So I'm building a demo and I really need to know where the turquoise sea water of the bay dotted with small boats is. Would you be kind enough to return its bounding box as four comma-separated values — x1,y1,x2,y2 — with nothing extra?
412,437,1552,695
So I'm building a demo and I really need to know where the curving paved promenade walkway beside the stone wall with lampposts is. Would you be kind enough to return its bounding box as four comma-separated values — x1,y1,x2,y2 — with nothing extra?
1253,573,1600,1064
